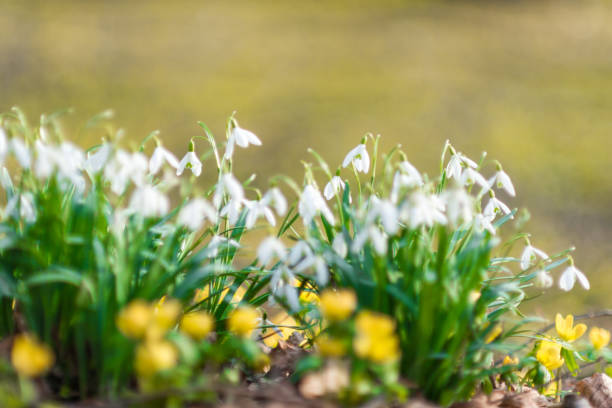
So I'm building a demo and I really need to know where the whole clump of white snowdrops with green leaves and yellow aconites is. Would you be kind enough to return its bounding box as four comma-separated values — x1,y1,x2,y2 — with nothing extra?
0,109,612,404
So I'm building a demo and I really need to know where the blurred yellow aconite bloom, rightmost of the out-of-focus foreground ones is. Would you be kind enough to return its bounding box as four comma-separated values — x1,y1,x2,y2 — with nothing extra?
353,311,400,363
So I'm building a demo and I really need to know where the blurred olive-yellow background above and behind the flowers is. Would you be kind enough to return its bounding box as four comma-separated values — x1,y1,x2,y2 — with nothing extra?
0,0,612,316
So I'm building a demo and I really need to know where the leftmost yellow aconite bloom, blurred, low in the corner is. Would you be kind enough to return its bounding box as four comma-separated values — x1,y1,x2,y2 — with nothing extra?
11,334,55,377
